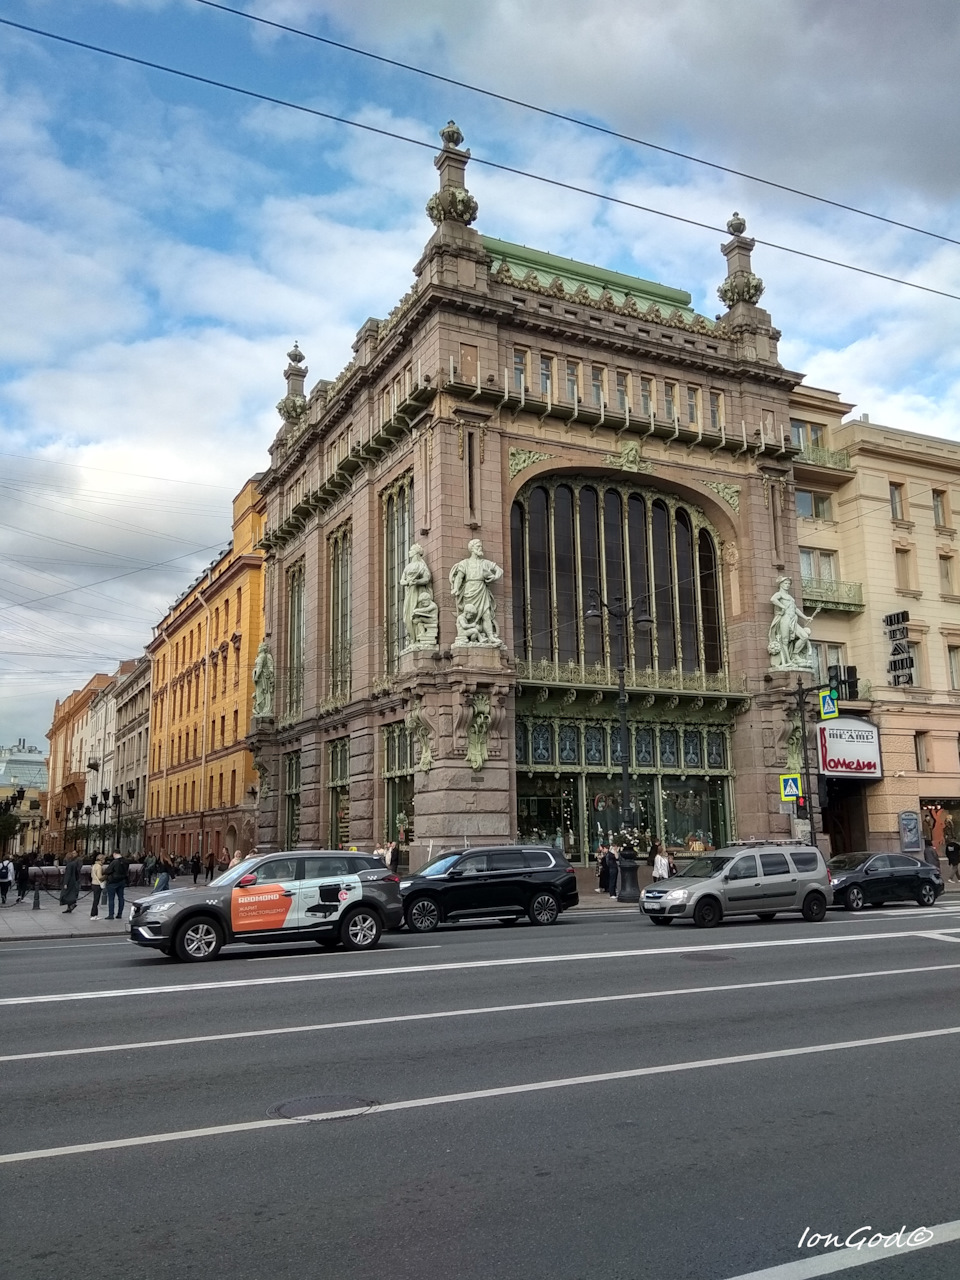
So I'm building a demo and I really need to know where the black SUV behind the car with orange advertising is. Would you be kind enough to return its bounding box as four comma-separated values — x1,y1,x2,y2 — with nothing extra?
401,845,580,933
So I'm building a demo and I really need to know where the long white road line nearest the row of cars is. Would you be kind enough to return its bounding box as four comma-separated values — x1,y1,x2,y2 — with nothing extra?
0,929,960,1007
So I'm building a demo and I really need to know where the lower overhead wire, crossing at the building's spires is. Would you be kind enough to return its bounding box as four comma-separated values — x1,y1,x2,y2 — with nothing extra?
0,18,960,302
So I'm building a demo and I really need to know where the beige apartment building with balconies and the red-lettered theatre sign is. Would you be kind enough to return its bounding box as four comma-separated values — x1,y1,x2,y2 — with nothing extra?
791,388,960,849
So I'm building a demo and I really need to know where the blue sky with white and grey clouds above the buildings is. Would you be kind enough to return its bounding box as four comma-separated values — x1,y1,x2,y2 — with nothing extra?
0,0,960,746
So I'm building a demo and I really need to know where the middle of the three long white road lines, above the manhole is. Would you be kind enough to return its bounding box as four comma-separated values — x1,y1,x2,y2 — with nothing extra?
0,964,960,1064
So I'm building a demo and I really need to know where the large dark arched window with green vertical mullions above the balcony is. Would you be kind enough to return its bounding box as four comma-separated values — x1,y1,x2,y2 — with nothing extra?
511,480,723,685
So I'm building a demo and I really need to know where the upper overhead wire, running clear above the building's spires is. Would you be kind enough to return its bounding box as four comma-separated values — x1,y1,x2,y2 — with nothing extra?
196,0,960,253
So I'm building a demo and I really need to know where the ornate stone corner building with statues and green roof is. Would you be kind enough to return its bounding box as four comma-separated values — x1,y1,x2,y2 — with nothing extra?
251,124,819,865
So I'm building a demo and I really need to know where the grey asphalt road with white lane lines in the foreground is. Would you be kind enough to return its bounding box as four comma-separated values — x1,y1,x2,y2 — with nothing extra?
0,905,960,1280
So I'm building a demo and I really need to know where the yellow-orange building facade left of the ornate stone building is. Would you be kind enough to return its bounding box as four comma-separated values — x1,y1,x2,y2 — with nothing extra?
146,476,264,860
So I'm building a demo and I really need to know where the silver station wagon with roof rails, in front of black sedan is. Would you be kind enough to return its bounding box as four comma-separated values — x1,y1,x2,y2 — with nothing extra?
640,841,831,929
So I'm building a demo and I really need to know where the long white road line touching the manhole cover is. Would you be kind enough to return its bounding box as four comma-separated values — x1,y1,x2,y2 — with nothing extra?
0,1027,960,1165
